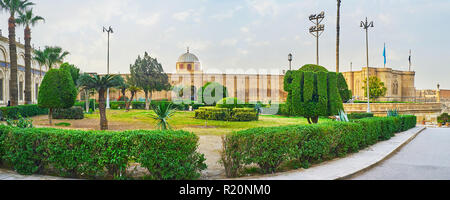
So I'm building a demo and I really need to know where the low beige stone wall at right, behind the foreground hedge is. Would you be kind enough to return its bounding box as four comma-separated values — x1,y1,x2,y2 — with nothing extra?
344,103,446,123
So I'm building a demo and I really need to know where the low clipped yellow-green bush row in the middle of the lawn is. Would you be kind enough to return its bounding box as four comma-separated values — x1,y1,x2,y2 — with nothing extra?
195,107,259,121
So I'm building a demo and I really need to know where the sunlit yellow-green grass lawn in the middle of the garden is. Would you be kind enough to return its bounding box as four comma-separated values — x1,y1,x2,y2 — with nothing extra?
85,110,329,135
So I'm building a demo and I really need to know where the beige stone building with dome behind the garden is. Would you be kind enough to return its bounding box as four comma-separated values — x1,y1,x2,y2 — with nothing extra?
110,49,287,103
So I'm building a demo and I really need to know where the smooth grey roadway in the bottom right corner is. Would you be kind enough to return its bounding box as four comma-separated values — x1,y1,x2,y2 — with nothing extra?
353,128,450,180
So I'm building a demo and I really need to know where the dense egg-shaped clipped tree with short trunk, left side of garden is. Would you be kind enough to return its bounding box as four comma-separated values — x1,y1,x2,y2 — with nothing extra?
38,69,77,125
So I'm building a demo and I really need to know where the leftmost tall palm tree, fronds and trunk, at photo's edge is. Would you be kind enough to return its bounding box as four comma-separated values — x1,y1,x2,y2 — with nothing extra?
0,0,34,106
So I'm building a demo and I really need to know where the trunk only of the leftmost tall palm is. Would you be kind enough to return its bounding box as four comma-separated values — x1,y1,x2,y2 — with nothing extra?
8,16,19,106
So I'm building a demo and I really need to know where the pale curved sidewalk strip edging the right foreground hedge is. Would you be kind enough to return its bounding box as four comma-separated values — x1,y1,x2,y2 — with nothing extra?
241,127,425,180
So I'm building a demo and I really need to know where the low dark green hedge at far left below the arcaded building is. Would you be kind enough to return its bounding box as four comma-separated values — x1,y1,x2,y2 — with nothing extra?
0,105,48,120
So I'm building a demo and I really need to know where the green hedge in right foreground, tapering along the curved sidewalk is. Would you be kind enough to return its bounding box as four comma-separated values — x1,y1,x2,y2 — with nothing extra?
222,116,416,177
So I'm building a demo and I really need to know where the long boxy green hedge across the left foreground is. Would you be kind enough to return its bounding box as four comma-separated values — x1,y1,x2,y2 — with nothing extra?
0,125,206,180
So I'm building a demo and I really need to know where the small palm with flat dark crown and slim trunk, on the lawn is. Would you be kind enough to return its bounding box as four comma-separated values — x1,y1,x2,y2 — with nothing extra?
78,74,123,130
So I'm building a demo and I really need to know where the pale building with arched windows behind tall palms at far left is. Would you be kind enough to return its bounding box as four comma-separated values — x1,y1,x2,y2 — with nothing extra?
0,34,45,106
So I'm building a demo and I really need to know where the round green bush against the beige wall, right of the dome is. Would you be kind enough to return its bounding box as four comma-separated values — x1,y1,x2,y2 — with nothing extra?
198,82,228,106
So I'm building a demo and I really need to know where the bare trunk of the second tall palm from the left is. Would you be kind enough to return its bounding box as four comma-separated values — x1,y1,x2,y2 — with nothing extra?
25,26,32,104
